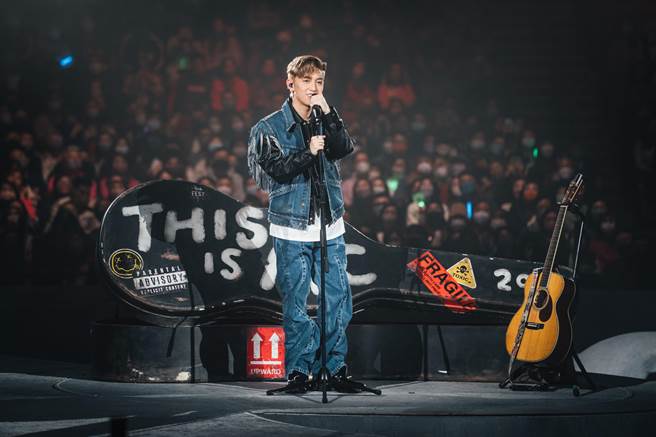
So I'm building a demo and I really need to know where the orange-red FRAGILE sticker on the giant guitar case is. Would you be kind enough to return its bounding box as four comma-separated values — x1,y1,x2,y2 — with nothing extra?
407,251,477,313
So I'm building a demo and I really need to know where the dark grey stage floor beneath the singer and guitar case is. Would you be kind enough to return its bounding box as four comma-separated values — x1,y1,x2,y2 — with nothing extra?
0,356,656,437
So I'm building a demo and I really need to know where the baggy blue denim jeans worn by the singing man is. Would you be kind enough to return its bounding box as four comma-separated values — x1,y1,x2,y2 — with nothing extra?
272,235,353,376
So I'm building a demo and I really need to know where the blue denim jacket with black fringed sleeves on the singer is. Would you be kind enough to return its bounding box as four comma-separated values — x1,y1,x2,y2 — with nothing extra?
248,100,353,229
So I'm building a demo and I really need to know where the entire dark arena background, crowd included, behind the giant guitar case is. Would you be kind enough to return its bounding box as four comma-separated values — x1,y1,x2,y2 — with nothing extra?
0,0,656,288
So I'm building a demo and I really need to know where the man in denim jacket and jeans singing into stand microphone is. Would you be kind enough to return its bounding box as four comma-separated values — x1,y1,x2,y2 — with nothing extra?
248,55,353,393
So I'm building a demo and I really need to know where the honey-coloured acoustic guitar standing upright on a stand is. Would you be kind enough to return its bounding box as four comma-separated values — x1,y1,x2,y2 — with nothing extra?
506,174,583,375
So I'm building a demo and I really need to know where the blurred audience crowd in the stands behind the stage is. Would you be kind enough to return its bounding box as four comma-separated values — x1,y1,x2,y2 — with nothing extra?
0,1,656,288
